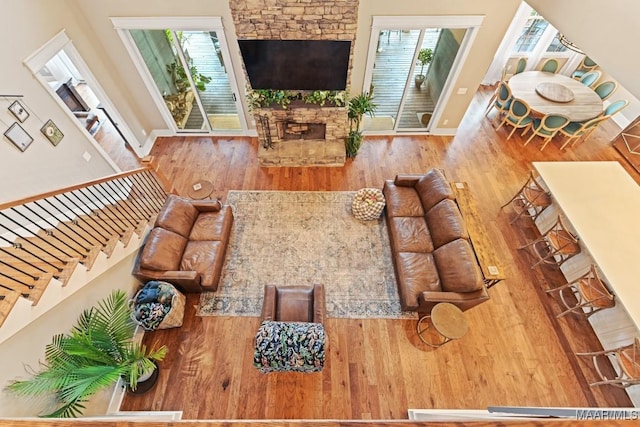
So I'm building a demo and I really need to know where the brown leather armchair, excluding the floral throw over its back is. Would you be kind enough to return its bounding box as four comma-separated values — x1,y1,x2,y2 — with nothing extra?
262,285,326,323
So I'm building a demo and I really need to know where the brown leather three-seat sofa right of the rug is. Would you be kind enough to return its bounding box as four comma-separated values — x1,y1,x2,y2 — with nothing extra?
382,169,489,312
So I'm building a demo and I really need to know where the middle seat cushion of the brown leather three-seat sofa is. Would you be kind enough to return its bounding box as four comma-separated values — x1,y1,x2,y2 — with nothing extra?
387,216,433,253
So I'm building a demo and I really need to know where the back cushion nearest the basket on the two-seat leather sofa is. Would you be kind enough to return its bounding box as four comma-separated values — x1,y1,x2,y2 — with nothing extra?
140,227,187,271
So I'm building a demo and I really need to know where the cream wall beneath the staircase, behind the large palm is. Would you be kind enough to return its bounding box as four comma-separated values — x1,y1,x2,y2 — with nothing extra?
0,252,138,417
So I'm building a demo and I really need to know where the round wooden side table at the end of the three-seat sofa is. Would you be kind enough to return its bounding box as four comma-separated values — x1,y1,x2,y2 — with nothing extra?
416,302,469,348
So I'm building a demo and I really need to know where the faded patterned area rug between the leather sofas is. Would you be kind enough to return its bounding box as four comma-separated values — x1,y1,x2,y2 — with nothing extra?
198,191,414,318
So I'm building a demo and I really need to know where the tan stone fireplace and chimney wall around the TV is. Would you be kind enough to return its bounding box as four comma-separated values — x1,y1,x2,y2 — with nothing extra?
229,0,358,166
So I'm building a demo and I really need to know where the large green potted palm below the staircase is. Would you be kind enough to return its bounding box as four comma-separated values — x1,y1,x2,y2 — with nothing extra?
7,290,167,417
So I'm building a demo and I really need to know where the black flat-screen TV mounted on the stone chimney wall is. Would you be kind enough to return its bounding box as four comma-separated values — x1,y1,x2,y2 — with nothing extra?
238,40,351,90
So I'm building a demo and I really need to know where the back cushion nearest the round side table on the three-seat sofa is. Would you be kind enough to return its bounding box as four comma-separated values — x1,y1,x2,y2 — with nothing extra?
433,239,483,292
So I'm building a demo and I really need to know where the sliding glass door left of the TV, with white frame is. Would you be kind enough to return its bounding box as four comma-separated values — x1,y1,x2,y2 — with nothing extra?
112,17,247,132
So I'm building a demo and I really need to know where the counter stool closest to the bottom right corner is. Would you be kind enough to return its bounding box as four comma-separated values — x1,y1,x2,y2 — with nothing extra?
576,337,640,388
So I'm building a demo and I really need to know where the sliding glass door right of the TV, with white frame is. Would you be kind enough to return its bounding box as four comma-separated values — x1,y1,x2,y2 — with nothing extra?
363,17,482,132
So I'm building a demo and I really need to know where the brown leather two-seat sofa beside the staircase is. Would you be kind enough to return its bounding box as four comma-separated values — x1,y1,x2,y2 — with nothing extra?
132,194,233,293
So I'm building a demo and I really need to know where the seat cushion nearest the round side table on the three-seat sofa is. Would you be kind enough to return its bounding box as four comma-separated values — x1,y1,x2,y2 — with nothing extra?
395,252,442,310
